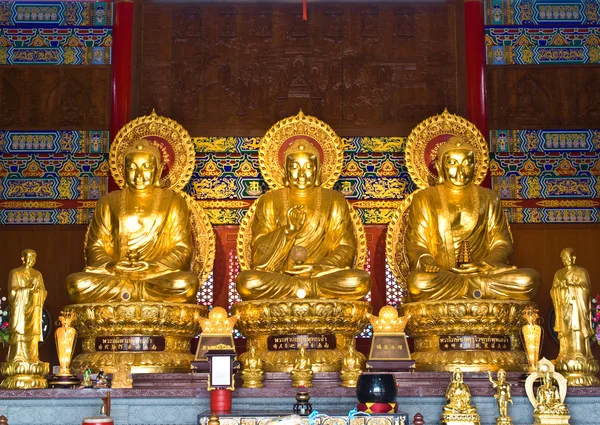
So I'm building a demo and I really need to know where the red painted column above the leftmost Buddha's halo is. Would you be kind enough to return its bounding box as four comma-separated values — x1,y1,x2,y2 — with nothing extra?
110,0,133,142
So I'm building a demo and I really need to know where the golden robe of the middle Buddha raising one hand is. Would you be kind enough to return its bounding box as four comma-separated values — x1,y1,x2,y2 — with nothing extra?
236,188,371,300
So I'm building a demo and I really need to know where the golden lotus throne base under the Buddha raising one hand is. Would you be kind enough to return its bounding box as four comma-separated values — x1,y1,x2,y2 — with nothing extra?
232,299,371,372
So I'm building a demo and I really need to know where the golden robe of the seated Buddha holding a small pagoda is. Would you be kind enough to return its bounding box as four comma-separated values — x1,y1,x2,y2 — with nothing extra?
405,186,540,301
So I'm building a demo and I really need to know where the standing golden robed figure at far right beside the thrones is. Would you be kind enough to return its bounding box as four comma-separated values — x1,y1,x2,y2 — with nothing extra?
550,248,594,359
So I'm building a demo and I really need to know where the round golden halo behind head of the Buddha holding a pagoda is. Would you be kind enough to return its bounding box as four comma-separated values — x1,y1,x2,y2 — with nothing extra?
405,109,490,189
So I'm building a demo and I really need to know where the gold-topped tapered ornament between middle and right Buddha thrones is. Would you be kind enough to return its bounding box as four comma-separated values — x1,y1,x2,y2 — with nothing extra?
367,305,414,371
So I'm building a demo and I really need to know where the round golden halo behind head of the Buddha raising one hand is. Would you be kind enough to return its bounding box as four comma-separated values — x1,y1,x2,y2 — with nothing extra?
258,111,344,189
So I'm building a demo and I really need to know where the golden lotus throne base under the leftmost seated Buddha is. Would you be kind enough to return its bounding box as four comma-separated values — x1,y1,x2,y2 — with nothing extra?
67,302,208,388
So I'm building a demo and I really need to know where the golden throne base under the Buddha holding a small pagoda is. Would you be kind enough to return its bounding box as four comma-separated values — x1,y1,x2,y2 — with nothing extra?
401,300,532,372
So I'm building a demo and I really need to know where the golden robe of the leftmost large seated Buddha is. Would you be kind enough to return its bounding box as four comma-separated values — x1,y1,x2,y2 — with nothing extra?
67,189,199,303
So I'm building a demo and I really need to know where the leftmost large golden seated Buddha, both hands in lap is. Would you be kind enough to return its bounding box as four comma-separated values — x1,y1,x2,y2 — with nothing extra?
67,139,199,303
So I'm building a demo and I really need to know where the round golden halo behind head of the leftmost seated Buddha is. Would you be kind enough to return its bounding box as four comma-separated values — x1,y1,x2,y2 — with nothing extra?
109,111,196,190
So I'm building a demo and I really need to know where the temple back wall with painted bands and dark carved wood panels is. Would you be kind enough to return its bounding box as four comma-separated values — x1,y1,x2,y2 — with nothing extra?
0,0,600,372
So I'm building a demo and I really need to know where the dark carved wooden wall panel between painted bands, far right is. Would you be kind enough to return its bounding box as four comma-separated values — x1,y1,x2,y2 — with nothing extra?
488,66,600,130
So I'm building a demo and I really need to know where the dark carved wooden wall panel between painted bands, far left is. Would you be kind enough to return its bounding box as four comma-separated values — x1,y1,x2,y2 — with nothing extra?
0,66,110,130
